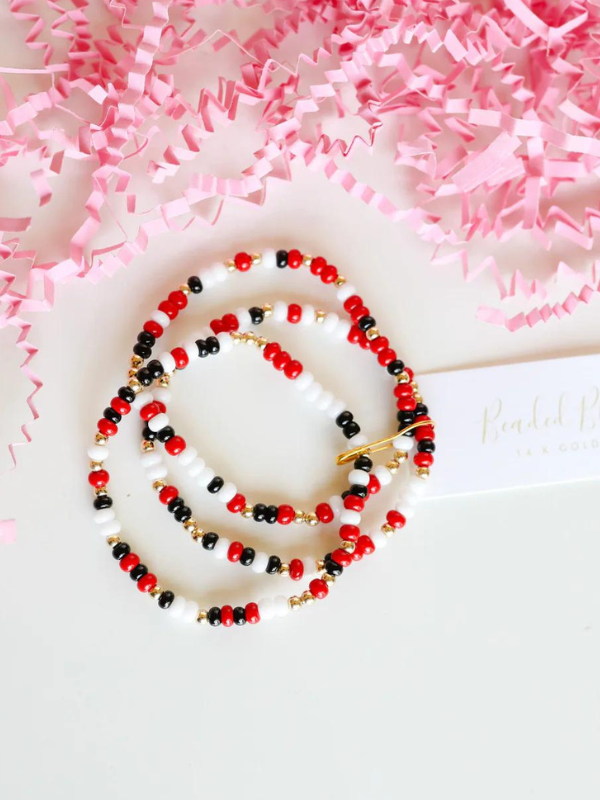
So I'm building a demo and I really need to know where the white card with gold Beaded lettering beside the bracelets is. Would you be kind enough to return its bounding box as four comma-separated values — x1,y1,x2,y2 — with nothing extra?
418,355,600,496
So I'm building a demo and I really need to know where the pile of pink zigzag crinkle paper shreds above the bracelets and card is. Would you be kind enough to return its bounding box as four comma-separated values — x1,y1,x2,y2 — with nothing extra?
0,0,600,500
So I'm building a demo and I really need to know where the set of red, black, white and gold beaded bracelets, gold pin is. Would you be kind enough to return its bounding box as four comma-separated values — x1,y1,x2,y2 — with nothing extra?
88,250,435,627
